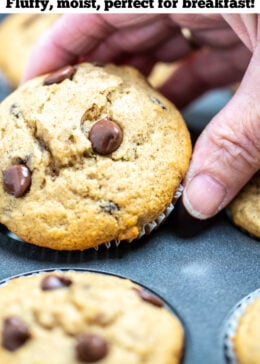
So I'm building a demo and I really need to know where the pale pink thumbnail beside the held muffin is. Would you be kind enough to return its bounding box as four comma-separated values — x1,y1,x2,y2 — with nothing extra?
183,173,226,219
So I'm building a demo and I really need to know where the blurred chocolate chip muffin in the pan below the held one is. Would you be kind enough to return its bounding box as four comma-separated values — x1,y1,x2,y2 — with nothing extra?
0,272,183,364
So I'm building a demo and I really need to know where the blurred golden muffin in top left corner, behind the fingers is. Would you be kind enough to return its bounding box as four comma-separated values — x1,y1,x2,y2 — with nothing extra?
0,14,60,86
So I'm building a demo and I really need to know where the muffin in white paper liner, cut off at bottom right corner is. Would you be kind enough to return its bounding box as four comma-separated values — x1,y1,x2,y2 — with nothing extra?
225,289,260,364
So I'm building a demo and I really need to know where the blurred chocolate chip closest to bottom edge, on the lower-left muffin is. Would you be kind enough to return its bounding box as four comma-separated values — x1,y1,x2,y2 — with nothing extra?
76,334,108,363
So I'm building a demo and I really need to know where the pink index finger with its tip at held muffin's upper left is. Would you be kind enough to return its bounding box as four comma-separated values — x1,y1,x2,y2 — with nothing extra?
23,14,158,81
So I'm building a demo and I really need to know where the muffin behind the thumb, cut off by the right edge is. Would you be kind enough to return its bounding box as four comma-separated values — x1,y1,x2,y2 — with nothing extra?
229,171,260,238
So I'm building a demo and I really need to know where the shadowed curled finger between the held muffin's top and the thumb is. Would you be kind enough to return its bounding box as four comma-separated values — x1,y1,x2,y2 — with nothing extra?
160,43,252,108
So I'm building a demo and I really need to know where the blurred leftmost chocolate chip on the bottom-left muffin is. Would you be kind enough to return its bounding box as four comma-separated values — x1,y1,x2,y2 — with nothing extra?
2,316,31,351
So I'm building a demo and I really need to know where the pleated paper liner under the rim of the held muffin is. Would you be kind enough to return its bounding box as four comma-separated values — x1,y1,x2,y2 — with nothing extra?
0,185,183,251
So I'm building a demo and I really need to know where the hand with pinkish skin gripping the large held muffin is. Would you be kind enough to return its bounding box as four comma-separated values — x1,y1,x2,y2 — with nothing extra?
24,14,260,219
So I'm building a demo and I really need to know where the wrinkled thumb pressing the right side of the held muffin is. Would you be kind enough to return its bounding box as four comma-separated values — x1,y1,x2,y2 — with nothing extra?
183,45,260,219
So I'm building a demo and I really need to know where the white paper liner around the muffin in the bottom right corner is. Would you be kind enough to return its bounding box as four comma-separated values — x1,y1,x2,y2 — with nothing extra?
223,288,260,364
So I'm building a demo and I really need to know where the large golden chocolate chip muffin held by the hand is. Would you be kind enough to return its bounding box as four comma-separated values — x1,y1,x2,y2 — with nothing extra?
0,64,191,250
